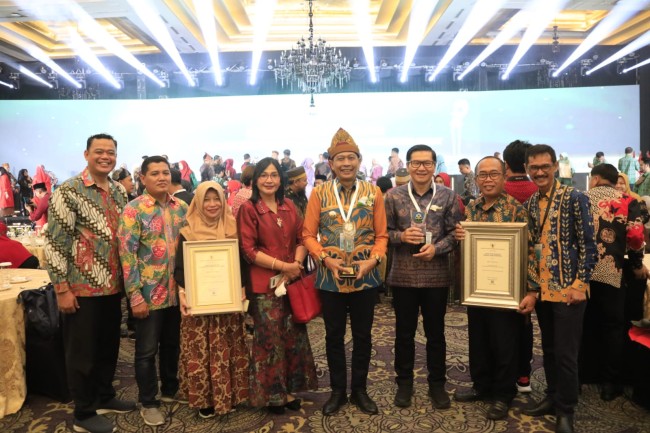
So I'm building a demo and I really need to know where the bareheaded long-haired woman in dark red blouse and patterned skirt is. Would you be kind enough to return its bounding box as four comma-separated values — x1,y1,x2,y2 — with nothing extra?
237,158,318,414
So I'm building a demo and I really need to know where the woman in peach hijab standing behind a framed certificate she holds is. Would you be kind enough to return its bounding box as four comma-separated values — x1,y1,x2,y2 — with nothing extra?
174,181,249,418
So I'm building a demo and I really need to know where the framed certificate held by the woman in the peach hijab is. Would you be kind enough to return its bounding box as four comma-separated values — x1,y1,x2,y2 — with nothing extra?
183,239,244,315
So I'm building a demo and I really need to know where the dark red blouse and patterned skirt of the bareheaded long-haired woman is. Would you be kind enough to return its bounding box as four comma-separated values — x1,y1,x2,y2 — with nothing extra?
237,200,318,407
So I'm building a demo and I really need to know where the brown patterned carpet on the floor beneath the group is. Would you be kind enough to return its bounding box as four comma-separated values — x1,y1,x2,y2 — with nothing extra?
0,301,650,433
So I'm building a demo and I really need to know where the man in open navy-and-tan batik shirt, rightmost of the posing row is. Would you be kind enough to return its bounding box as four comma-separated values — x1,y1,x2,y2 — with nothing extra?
523,144,596,433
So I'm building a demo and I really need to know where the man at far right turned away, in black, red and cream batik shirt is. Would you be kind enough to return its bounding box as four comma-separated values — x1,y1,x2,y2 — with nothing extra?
580,164,646,401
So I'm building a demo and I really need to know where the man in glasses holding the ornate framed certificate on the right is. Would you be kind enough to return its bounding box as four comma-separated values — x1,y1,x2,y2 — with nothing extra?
454,156,537,420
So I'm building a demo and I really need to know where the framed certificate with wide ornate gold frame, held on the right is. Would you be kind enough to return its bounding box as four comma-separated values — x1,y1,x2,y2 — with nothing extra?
461,221,528,310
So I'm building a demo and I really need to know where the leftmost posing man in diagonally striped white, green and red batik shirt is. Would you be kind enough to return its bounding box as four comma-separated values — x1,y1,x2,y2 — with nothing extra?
45,134,135,432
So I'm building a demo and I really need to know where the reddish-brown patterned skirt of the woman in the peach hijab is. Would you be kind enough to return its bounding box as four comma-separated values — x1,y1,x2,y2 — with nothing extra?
179,314,249,415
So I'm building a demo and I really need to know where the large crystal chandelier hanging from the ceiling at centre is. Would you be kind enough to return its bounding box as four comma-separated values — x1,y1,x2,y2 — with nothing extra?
273,0,351,95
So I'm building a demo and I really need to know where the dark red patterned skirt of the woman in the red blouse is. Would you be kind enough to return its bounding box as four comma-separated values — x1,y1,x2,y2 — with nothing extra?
248,293,318,407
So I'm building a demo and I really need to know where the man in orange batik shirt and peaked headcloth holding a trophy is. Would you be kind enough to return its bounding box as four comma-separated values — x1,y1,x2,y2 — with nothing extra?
303,128,388,416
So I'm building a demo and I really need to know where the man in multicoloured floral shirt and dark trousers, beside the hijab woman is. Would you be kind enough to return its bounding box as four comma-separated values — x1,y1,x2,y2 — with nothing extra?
118,156,187,426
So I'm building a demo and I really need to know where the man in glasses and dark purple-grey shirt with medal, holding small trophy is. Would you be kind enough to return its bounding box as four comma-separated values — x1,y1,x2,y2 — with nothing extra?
385,144,461,409
